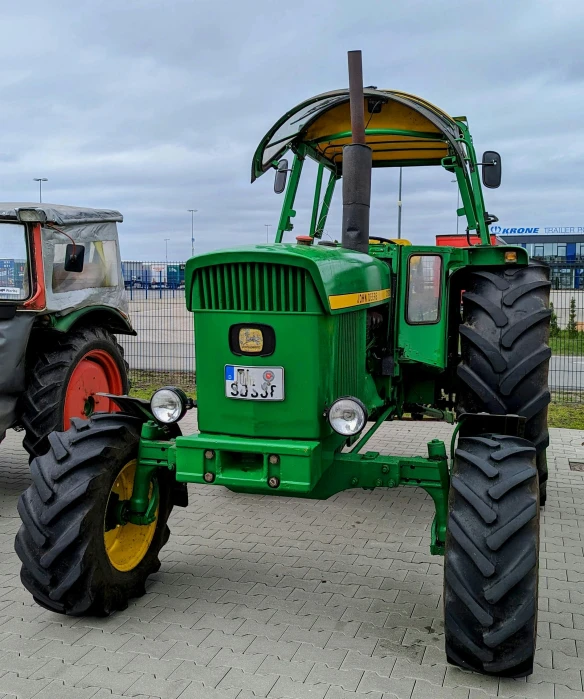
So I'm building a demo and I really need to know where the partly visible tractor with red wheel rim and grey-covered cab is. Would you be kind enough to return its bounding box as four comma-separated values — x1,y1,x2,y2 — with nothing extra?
0,203,131,458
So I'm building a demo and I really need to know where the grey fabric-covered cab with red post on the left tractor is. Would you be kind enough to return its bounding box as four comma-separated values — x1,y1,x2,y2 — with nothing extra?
0,203,128,316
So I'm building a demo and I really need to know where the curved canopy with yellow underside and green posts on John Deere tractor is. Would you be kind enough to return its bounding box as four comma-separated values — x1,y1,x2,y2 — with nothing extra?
251,87,500,245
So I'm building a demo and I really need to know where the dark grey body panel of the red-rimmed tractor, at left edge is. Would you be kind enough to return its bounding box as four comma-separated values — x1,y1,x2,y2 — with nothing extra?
0,308,35,441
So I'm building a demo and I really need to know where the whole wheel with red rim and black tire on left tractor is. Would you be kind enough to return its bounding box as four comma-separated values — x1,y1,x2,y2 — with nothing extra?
21,327,129,458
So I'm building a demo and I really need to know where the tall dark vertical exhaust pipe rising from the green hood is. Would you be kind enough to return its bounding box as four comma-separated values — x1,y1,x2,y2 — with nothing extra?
342,51,372,252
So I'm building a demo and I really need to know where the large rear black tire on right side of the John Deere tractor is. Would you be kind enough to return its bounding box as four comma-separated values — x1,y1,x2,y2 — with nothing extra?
457,262,551,506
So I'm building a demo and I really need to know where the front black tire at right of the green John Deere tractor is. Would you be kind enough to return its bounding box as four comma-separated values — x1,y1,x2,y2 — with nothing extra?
444,435,539,677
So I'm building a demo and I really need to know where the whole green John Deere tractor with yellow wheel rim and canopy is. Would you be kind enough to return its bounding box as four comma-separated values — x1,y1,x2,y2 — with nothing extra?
16,52,550,676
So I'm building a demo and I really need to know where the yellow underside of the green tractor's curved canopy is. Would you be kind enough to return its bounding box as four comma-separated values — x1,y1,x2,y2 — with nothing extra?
302,96,448,163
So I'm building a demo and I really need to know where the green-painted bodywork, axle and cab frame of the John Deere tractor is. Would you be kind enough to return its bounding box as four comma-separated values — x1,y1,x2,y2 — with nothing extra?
129,87,540,553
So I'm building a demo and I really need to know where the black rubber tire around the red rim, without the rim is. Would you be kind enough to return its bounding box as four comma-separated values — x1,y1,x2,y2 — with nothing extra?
20,327,129,459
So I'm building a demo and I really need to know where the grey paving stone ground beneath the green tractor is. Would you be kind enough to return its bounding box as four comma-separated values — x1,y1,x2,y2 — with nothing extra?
0,416,584,699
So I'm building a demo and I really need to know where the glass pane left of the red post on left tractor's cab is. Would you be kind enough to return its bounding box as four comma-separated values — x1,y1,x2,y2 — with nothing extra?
0,223,30,302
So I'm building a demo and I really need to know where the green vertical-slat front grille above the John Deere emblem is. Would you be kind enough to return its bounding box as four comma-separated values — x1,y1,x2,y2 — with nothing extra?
193,262,312,313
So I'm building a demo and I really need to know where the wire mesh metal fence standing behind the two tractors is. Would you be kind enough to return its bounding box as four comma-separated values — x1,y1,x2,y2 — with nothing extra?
120,262,584,403
